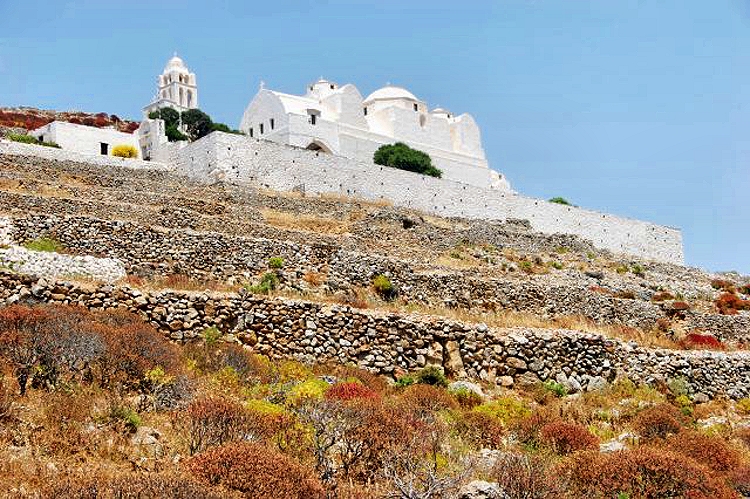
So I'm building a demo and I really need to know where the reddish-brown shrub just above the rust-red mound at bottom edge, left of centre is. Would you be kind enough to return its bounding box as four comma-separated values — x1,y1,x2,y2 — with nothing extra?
177,397,247,455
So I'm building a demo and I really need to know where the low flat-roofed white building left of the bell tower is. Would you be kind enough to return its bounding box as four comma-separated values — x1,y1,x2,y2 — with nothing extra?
30,121,141,157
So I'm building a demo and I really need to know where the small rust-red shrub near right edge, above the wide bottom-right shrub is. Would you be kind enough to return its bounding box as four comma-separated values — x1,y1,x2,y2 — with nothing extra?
666,431,742,473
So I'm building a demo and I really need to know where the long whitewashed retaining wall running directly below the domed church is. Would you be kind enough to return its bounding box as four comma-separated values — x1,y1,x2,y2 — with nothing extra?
177,132,684,264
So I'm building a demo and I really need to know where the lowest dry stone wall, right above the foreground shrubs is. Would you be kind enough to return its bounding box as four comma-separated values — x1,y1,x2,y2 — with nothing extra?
0,271,750,398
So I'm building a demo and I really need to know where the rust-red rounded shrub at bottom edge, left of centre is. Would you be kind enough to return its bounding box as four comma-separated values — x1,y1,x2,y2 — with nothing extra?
185,442,325,499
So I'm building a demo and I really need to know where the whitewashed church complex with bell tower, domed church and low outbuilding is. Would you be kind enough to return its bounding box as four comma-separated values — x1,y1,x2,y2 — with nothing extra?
27,53,510,191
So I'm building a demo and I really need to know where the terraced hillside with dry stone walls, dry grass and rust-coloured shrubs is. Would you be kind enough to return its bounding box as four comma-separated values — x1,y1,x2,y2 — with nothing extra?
0,146,750,499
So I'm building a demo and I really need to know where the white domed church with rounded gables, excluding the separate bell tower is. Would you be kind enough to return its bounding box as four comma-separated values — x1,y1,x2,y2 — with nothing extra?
240,78,510,190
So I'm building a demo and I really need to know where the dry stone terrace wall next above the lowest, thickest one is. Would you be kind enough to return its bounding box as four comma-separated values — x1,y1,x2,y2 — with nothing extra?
12,215,750,341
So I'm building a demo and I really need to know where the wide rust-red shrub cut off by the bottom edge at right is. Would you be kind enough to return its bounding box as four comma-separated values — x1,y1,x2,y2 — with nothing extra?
559,446,736,499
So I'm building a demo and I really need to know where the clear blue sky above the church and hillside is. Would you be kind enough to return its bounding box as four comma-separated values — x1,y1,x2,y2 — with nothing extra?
0,0,750,273
